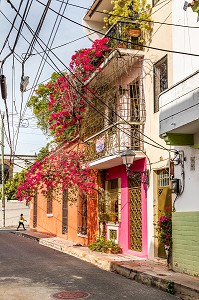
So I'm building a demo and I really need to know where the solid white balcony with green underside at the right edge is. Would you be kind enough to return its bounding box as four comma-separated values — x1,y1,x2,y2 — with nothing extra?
159,71,199,148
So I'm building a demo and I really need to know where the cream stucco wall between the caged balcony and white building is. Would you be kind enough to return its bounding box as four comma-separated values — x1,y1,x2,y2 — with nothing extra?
143,0,173,259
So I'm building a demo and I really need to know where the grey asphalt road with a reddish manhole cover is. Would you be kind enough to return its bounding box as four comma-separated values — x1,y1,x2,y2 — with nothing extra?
0,230,177,300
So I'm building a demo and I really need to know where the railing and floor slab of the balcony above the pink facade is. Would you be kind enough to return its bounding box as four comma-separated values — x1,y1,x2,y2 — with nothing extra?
85,123,144,169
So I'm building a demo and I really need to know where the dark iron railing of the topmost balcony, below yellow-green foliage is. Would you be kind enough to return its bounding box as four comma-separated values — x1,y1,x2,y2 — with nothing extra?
105,21,143,50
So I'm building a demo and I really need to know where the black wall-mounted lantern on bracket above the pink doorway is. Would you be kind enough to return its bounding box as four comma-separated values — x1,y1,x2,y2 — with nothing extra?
121,147,149,184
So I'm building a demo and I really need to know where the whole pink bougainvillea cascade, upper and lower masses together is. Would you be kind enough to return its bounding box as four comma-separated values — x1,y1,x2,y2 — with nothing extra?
17,38,111,201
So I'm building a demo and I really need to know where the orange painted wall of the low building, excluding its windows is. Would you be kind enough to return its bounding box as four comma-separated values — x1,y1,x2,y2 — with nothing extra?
30,185,98,245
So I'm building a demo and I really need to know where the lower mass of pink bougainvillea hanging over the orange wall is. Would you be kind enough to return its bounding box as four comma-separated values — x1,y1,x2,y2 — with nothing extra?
17,146,94,201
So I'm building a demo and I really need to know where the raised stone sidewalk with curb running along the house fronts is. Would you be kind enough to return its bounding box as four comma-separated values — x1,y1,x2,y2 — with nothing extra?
13,230,199,300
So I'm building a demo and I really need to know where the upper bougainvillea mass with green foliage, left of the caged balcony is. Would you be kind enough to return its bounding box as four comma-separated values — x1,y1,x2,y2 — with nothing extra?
28,38,111,143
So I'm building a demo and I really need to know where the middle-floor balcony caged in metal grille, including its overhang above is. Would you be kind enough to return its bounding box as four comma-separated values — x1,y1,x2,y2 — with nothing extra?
80,54,146,162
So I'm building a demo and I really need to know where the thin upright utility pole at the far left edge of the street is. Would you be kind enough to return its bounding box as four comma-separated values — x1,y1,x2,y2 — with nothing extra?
1,113,5,227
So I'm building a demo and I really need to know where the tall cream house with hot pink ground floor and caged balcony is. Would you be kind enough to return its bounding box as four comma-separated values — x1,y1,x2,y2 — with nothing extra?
83,0,172,258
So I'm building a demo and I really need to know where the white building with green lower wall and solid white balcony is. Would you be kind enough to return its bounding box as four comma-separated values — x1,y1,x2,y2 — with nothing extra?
160,0,199,276
